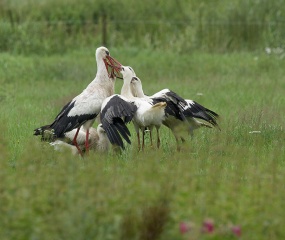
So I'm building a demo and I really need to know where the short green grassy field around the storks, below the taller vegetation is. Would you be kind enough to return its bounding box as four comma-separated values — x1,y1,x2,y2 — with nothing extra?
0,46,285,240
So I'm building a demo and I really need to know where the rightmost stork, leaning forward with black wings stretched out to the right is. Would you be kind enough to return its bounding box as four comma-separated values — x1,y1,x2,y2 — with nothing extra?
131,78,219,147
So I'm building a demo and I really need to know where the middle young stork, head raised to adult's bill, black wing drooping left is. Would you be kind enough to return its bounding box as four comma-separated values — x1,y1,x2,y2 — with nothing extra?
101,67,166,150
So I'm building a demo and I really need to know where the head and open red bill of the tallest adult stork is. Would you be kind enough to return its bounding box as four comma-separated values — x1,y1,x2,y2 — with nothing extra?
96,47,122,78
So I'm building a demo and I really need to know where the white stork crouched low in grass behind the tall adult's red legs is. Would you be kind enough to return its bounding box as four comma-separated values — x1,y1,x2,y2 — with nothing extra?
50,124,110,155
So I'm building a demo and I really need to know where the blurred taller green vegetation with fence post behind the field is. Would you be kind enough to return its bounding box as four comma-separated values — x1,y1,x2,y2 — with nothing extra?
0,0,285,54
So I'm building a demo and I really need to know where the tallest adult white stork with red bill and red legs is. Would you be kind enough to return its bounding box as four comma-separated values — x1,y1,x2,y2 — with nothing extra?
34,47,121,153
